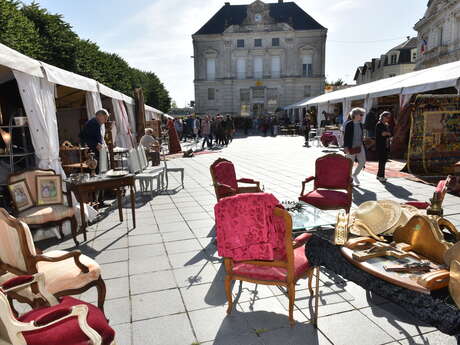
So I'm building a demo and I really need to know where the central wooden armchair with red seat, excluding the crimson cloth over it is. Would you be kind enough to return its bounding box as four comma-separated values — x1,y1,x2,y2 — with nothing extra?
216,194,313,326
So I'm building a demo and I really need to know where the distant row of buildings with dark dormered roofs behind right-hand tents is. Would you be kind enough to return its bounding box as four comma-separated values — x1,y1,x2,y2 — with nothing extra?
354,37,418,85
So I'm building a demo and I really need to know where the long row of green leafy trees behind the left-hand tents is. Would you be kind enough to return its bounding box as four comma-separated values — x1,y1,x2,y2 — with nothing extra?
0,0,171,112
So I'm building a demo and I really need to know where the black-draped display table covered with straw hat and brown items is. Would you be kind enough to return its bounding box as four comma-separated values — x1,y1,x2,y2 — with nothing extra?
305,201,460,339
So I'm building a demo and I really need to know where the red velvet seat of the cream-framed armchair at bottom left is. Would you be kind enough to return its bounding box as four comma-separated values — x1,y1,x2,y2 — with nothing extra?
19,297,115,345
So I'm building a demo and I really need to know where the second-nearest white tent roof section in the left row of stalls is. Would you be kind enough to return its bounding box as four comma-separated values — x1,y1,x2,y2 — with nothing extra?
40,62,98,92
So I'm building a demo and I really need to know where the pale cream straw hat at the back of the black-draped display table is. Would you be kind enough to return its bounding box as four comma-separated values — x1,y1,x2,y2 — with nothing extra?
350,200,402,236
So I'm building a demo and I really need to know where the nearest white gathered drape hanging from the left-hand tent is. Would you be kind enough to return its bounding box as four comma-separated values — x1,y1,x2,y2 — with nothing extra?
13,71,65,177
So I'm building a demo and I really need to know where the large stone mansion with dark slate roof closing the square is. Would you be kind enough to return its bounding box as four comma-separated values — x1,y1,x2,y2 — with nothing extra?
192,0,327,116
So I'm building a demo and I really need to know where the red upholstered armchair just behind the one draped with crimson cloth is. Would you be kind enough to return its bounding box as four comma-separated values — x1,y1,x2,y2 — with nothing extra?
209,158,262,201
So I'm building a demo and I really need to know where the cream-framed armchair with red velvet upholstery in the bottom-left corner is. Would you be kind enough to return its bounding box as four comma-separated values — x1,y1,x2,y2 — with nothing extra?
0,274,115,345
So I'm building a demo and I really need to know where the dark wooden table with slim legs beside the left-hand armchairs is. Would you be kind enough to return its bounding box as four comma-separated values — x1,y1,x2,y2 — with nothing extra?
64,174,136,241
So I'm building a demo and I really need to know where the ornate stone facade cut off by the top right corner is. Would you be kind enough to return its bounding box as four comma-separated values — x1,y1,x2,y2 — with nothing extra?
414,0,460,70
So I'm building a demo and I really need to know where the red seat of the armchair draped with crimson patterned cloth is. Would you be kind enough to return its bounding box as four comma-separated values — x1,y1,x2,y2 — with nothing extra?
233,246,310,282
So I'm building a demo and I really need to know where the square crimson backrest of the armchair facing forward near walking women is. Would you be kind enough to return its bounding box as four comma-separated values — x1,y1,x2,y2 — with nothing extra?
315,155,353,189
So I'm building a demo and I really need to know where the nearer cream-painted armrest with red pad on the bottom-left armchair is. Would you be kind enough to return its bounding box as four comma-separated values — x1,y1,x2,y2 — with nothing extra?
15,304,102,344
